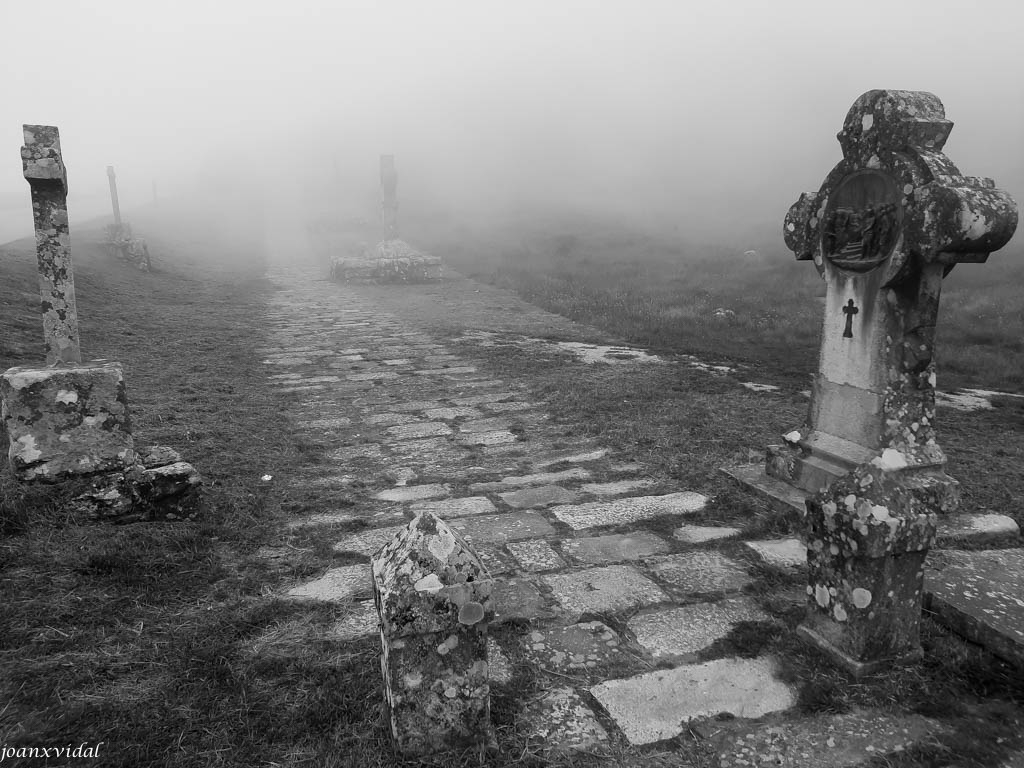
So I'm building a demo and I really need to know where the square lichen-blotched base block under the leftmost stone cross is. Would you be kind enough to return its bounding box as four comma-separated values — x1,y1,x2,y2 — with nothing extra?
0,360,135,482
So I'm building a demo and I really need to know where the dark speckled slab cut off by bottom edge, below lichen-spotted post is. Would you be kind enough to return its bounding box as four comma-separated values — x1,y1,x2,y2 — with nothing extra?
716,710,947,768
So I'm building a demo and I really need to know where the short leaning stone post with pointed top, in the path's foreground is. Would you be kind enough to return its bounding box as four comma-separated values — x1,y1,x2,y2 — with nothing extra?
372,513,494,755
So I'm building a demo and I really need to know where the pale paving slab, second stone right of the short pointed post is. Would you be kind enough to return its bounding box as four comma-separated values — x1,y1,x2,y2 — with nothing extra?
542,565,669,618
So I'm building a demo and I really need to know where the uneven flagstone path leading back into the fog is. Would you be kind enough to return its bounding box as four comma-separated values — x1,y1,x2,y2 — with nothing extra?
253,260,1015,766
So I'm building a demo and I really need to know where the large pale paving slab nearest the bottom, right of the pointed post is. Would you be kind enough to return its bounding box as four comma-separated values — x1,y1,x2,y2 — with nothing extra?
590,657,797,744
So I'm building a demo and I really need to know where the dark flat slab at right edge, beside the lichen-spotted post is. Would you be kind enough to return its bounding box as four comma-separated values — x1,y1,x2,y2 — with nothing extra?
924,549,1024,669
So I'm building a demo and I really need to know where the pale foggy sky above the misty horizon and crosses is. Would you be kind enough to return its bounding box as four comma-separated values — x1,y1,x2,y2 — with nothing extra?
0,0,1024,247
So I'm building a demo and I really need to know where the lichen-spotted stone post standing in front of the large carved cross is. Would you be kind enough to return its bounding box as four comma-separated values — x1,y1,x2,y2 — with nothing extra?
798,459,955,676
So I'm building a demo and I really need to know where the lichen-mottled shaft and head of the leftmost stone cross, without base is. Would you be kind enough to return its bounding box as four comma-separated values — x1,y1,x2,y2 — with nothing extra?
22,125,82,365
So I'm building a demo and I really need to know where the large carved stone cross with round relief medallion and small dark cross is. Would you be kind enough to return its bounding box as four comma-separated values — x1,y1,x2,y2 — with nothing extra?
767,90,1017,493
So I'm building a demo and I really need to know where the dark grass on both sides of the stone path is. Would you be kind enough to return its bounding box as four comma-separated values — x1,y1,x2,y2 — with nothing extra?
0,207,1024,768
